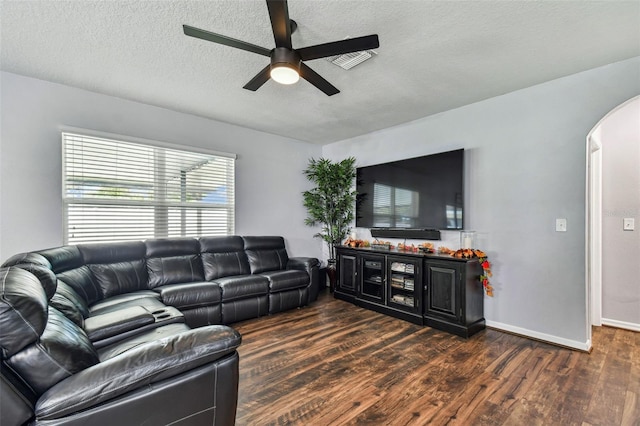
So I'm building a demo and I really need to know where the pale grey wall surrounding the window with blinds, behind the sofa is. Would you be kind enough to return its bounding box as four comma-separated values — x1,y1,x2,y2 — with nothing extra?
0,72,321,260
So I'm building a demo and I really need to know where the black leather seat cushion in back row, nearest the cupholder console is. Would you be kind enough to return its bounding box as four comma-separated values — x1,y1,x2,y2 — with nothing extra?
154,281,222,309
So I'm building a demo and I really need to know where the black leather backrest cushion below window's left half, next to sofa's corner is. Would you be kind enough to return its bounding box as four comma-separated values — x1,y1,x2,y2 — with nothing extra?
78,241,149,304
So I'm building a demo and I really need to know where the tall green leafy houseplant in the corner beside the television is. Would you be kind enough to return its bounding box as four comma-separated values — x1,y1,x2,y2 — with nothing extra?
302,157,357,260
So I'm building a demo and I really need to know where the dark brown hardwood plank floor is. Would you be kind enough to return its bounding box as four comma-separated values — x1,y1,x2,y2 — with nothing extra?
234,292,640,426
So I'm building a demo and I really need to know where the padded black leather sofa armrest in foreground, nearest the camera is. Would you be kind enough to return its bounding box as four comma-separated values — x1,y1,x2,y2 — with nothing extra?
35,325,241,420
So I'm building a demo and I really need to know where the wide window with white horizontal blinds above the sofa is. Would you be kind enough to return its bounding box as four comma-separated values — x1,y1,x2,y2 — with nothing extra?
62,133,235,244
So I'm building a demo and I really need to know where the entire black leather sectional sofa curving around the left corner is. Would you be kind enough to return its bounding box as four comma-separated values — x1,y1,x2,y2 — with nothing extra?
0,236,319,426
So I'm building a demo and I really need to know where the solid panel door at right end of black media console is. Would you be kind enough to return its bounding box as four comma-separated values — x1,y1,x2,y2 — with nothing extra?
424,261,463,322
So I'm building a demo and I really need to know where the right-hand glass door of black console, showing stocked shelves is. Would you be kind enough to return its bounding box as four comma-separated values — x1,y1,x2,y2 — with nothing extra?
387,256,422,313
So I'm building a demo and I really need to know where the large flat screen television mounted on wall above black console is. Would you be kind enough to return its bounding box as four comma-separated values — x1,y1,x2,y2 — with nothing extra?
356,149,464,230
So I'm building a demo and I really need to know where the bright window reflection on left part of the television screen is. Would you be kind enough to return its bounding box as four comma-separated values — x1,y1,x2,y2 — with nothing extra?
373,183,420,228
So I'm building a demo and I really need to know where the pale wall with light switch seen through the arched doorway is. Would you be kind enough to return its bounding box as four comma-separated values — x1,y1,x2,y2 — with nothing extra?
600,98,640,330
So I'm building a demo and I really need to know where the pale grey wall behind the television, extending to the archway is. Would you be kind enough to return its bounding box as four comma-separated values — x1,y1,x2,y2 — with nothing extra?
323,57,640,349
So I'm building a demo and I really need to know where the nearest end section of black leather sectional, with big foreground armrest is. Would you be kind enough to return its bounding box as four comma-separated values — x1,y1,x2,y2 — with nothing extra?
0,265,241,425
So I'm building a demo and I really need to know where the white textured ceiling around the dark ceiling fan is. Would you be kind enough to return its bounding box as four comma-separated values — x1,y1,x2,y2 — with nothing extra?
0,0,640,144
